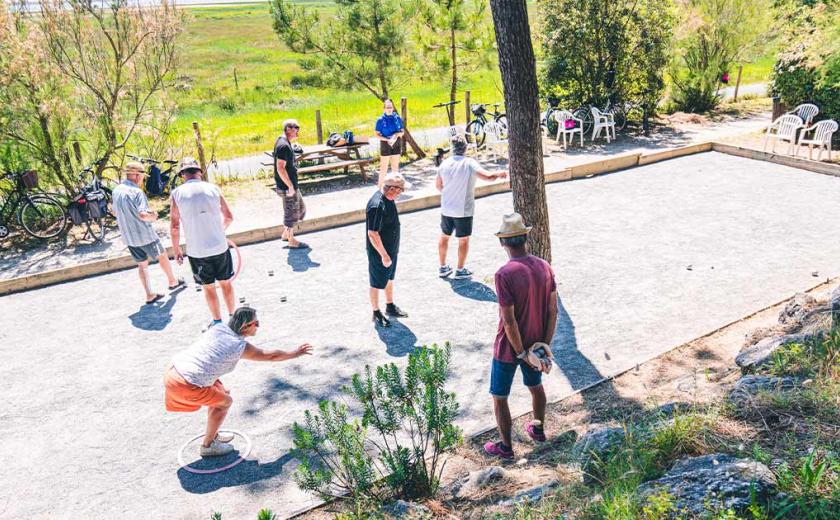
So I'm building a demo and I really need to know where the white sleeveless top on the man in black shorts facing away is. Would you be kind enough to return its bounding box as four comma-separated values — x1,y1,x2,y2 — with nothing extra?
172,179,228,258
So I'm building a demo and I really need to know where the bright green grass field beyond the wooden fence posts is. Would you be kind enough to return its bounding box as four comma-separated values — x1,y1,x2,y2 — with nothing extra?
174,0,773,159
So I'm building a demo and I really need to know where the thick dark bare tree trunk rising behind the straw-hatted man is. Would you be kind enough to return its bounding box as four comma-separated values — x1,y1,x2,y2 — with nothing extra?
490,0,551,262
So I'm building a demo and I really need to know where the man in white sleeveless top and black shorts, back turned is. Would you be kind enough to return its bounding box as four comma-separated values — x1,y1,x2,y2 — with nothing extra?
169,157,234,326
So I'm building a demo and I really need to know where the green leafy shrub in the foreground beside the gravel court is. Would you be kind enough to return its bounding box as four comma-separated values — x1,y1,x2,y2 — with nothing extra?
293,344,462,509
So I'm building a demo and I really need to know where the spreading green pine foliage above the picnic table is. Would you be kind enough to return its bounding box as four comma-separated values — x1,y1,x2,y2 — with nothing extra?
271,0,406,100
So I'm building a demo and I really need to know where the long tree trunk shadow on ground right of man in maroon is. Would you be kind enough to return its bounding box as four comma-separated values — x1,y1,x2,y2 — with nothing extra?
551,297,644,413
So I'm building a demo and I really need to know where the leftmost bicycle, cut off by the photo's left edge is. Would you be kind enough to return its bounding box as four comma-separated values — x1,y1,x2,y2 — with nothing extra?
0,171,67,239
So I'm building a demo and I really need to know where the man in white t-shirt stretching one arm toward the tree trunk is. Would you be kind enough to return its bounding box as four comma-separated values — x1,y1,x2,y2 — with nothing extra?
435,135,507,280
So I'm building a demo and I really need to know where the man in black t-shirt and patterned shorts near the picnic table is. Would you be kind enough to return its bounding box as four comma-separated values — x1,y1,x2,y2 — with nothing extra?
274,119,309,249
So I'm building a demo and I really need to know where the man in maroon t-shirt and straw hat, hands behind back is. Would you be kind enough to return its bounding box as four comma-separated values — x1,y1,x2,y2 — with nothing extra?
484,213,557,459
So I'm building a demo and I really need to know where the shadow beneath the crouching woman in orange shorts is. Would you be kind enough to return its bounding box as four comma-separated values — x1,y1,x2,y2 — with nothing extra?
178,451,294,495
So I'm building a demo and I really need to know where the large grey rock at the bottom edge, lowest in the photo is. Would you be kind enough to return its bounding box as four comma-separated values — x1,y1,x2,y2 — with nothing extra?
636,454,776,518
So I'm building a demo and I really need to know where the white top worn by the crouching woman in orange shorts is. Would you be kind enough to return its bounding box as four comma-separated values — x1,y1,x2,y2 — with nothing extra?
172,323,246,386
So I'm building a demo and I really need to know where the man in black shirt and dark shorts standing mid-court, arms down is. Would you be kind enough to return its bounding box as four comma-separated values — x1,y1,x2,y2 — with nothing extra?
366,173,408,327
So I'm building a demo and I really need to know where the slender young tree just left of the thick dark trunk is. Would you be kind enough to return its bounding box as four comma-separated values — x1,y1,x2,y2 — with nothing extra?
412,0,494,125
